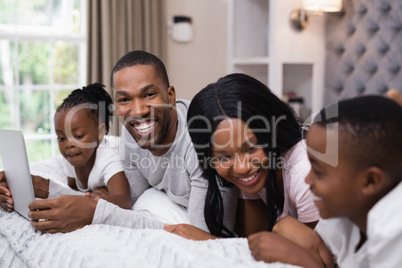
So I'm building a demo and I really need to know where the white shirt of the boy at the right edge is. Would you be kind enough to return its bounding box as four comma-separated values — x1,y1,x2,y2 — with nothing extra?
315,183,402,268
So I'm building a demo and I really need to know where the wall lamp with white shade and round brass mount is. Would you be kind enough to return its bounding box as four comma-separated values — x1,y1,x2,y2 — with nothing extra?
290,0,342,31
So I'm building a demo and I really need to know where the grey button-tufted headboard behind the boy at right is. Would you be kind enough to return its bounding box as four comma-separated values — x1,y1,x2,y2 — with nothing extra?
324,0,402,104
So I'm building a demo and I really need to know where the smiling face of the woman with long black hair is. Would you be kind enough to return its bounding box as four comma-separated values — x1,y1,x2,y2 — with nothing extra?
211,118,269,194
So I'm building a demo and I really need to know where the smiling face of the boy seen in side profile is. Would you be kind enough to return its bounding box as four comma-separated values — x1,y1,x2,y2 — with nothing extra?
306,124,363,220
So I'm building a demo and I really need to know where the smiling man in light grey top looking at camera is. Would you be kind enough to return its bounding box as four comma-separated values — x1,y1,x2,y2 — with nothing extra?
95,51,228,226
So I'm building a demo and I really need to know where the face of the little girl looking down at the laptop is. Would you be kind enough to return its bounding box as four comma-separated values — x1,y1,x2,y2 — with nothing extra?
54,108,104,168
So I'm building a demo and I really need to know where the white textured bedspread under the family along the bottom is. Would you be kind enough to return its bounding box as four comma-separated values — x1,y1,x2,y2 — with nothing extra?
0,209,294,268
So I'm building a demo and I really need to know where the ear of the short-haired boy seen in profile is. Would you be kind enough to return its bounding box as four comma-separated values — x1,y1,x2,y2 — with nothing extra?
362,167,388,196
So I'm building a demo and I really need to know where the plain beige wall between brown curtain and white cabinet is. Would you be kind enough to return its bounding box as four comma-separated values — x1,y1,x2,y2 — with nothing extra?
164,0,226,100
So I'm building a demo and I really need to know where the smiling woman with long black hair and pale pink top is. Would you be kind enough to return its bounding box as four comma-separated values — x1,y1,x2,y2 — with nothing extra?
165,74,319,239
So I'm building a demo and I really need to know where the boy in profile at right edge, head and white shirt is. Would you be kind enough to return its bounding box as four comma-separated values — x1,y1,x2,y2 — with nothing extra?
306,96,402,267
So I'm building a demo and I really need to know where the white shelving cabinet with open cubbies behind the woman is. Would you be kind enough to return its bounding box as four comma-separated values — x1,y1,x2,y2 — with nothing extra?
227,0,325,118
